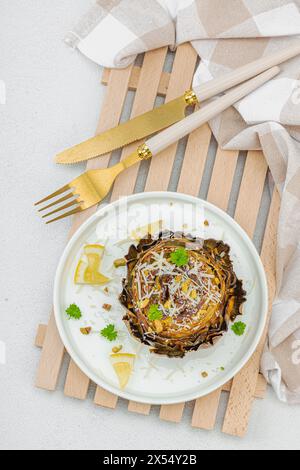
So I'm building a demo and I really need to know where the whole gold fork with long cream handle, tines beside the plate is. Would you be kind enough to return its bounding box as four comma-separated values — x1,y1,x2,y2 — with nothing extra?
35,67,279,224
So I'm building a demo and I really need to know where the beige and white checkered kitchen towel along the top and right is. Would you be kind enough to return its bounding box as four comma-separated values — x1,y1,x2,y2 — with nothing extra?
66,0,300,403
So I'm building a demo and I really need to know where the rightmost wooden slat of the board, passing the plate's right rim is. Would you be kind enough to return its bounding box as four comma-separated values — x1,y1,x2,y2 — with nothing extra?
222,190,280,437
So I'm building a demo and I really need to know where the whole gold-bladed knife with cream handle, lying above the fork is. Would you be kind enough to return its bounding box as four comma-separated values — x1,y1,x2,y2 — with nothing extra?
55,42,300,164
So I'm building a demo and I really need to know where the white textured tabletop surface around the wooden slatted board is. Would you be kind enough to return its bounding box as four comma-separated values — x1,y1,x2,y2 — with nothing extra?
0,0,300,450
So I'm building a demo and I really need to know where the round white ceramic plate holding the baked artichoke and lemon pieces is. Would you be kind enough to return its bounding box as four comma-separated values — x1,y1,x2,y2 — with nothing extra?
54,192,268,404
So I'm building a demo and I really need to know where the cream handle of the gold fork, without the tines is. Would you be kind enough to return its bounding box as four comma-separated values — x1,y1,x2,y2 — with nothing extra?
146,67,280,155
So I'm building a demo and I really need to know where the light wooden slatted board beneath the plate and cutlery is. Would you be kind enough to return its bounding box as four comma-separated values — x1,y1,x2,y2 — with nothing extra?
35,44,280,437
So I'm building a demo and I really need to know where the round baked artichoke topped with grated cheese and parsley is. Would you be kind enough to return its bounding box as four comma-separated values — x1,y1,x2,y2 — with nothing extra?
120,232,246,357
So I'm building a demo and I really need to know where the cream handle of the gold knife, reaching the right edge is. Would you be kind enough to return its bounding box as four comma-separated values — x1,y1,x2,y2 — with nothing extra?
194,42,300,103
